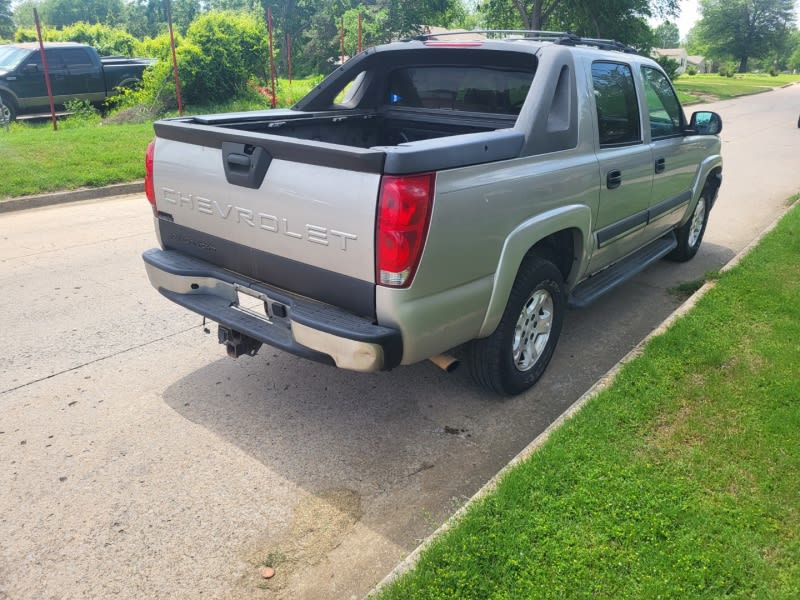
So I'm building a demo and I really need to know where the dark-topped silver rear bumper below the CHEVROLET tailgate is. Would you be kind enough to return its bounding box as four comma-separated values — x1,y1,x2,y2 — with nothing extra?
142,248,403,371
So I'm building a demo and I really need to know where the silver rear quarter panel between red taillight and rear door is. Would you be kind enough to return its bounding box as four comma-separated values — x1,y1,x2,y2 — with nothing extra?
376,151,598,364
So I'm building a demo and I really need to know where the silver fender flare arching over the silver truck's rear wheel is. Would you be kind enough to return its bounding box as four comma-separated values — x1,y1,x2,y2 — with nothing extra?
477,204,592,337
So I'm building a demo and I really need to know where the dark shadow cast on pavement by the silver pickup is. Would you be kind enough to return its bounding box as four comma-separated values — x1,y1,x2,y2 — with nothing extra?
156,237,732,576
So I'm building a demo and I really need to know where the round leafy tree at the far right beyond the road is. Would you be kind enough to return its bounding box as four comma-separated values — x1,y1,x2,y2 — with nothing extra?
697,0,795,73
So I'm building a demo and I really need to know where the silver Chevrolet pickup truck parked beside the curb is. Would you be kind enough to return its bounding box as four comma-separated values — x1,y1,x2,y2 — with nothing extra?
144,32,722,395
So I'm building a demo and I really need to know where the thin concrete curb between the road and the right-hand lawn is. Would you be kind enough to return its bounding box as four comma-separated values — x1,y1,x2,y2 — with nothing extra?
365,200,800,598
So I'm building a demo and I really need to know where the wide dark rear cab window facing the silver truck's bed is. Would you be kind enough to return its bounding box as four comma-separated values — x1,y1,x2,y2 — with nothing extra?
386,65,533,115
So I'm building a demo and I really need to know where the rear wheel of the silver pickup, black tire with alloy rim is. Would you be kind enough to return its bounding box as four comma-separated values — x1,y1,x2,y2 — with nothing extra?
466,256,567,396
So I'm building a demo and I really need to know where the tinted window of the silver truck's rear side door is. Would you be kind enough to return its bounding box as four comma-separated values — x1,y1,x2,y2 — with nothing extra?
592,62,642,146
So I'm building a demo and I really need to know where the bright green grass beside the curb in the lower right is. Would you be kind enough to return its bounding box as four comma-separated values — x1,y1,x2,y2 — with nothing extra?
379,198,800,600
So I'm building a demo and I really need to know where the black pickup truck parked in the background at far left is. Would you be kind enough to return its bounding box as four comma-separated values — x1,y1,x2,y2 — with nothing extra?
0,42,154,121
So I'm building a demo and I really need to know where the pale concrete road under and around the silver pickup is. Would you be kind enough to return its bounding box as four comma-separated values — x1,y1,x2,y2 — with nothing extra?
0,86,800,599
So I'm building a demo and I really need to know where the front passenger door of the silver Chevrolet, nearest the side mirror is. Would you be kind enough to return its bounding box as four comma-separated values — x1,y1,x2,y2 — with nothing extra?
641,66,702,238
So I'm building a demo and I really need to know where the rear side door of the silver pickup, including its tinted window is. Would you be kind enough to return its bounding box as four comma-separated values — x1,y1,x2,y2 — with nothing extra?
589,61,653,271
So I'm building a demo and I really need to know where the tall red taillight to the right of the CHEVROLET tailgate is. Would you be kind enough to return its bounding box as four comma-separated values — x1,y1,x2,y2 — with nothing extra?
375,173,436,287
